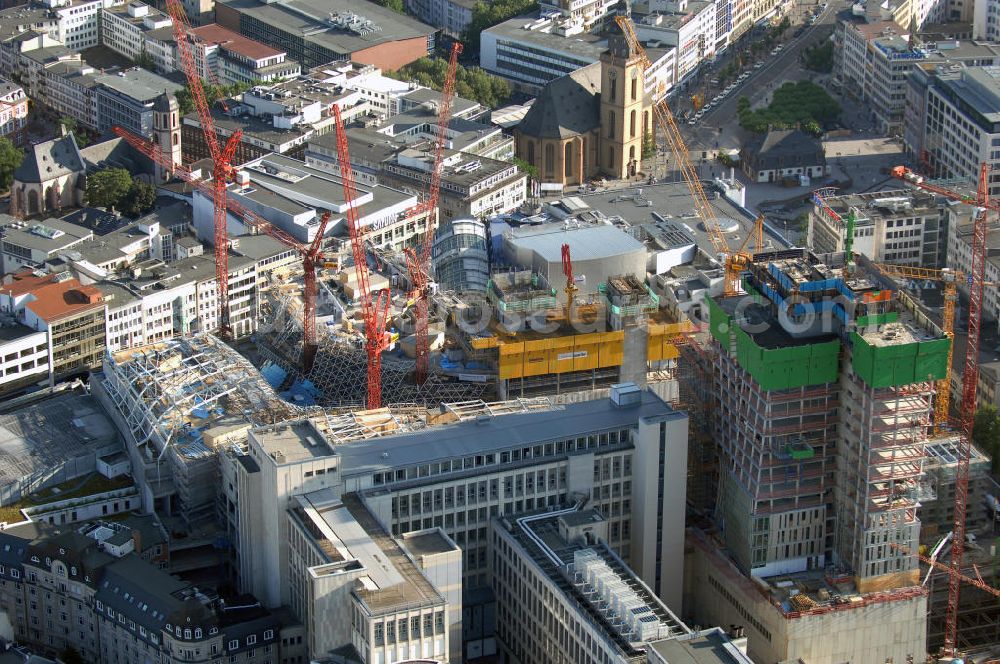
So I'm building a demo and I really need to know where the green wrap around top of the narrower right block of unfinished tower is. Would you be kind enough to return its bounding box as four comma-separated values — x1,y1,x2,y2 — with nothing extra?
851,332,951,387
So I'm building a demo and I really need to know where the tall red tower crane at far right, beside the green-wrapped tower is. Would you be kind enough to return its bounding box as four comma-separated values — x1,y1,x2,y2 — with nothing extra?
892,163,1000,656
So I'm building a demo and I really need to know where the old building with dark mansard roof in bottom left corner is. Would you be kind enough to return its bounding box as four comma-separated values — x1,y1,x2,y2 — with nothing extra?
0,521,292,664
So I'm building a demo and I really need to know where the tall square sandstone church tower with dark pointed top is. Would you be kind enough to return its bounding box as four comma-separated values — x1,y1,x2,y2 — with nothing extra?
598,0,649,179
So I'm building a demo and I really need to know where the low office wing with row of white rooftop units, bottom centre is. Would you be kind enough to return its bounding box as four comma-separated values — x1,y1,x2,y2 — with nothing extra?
489,504,750,664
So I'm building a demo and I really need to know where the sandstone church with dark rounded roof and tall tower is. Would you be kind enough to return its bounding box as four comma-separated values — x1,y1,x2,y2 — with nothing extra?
514,7,652,186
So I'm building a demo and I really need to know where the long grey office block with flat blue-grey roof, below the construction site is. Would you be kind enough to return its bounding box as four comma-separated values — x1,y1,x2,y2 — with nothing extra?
223,386,687,656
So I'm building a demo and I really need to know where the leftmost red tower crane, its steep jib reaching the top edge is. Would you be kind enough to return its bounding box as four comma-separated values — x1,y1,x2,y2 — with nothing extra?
166,0,242,336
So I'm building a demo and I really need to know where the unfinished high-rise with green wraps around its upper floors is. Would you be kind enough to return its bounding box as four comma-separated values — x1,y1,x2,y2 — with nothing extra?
694,250,950,662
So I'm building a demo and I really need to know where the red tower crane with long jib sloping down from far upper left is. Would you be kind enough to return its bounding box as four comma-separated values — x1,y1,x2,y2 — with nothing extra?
114,127,330,374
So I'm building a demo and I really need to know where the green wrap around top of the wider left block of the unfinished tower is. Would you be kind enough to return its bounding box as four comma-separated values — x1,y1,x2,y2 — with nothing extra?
708,299,840,391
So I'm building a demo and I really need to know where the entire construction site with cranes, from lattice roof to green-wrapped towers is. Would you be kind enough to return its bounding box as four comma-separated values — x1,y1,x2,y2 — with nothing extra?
76,0,1000,664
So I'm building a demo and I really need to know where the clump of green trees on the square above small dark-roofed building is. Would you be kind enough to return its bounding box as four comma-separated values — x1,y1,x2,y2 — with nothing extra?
736,81,840,136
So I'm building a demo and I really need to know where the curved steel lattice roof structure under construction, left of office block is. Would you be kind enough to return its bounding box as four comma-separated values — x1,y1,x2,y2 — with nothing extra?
100,333,308,527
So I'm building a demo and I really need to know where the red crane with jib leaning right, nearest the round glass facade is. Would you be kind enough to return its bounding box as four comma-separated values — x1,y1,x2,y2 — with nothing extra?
405,42,462,385
